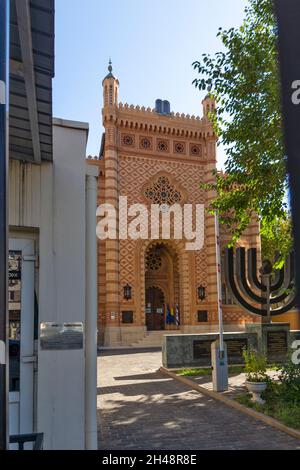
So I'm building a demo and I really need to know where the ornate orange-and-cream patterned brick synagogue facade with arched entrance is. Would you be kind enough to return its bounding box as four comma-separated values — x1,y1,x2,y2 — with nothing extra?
89,66,260,346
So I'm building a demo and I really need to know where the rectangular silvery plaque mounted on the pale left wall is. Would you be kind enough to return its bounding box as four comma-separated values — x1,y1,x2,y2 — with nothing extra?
40,322,83,351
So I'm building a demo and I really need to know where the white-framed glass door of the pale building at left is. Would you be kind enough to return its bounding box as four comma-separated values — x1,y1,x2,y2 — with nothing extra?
9,239,35,442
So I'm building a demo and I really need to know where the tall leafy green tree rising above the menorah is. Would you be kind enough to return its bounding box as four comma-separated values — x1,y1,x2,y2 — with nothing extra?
193,0,289,260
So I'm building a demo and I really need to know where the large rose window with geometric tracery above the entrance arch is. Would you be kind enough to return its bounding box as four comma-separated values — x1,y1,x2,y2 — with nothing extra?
145,176,182,206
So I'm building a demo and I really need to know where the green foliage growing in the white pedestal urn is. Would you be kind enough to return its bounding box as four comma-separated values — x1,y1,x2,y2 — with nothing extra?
243,346,269,382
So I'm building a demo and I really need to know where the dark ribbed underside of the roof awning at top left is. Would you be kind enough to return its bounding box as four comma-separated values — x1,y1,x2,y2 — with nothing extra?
9,0,54,163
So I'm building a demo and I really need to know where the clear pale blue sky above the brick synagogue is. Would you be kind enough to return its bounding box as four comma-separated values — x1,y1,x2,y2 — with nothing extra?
53,0,247,166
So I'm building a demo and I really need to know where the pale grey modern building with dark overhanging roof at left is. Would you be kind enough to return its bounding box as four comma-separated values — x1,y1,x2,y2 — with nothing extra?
9,0,98,449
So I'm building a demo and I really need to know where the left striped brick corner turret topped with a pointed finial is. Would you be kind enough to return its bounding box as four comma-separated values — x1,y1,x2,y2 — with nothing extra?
102,61,120,344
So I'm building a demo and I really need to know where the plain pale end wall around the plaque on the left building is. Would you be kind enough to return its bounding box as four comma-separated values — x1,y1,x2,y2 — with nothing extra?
37,120,88,449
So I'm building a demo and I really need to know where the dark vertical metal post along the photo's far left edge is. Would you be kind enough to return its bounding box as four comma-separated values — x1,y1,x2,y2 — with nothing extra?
0,0,9,450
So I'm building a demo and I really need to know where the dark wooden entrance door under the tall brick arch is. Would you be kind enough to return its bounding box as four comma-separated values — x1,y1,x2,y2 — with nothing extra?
146,287,165,331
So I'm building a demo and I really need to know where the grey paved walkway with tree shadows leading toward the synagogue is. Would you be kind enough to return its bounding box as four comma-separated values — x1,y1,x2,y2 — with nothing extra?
98,350,300,450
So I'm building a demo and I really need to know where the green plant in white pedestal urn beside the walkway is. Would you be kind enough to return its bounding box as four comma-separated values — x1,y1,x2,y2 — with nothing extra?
243,346,268,405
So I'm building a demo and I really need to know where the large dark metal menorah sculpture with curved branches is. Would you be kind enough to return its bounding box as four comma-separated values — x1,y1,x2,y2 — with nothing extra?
226,248,296,322
